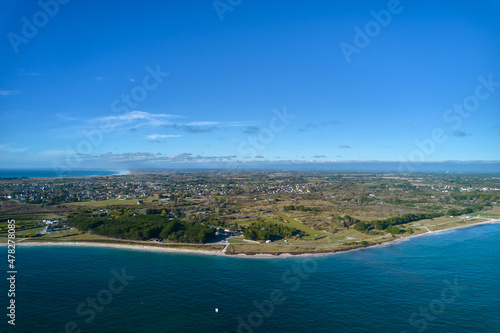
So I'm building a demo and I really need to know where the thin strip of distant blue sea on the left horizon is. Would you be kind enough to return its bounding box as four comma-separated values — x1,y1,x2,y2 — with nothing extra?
0,169,122,178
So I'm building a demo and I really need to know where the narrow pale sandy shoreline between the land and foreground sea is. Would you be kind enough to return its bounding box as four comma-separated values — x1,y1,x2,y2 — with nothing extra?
16,219,500,259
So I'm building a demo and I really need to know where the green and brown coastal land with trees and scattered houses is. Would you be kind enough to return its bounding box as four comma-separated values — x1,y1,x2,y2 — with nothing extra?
0,170,500,256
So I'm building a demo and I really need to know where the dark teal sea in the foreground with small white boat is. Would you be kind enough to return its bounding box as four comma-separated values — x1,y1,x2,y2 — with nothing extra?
4,224,500,333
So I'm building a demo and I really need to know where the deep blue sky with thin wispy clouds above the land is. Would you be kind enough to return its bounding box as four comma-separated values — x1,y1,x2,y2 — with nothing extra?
0,0,500,168
